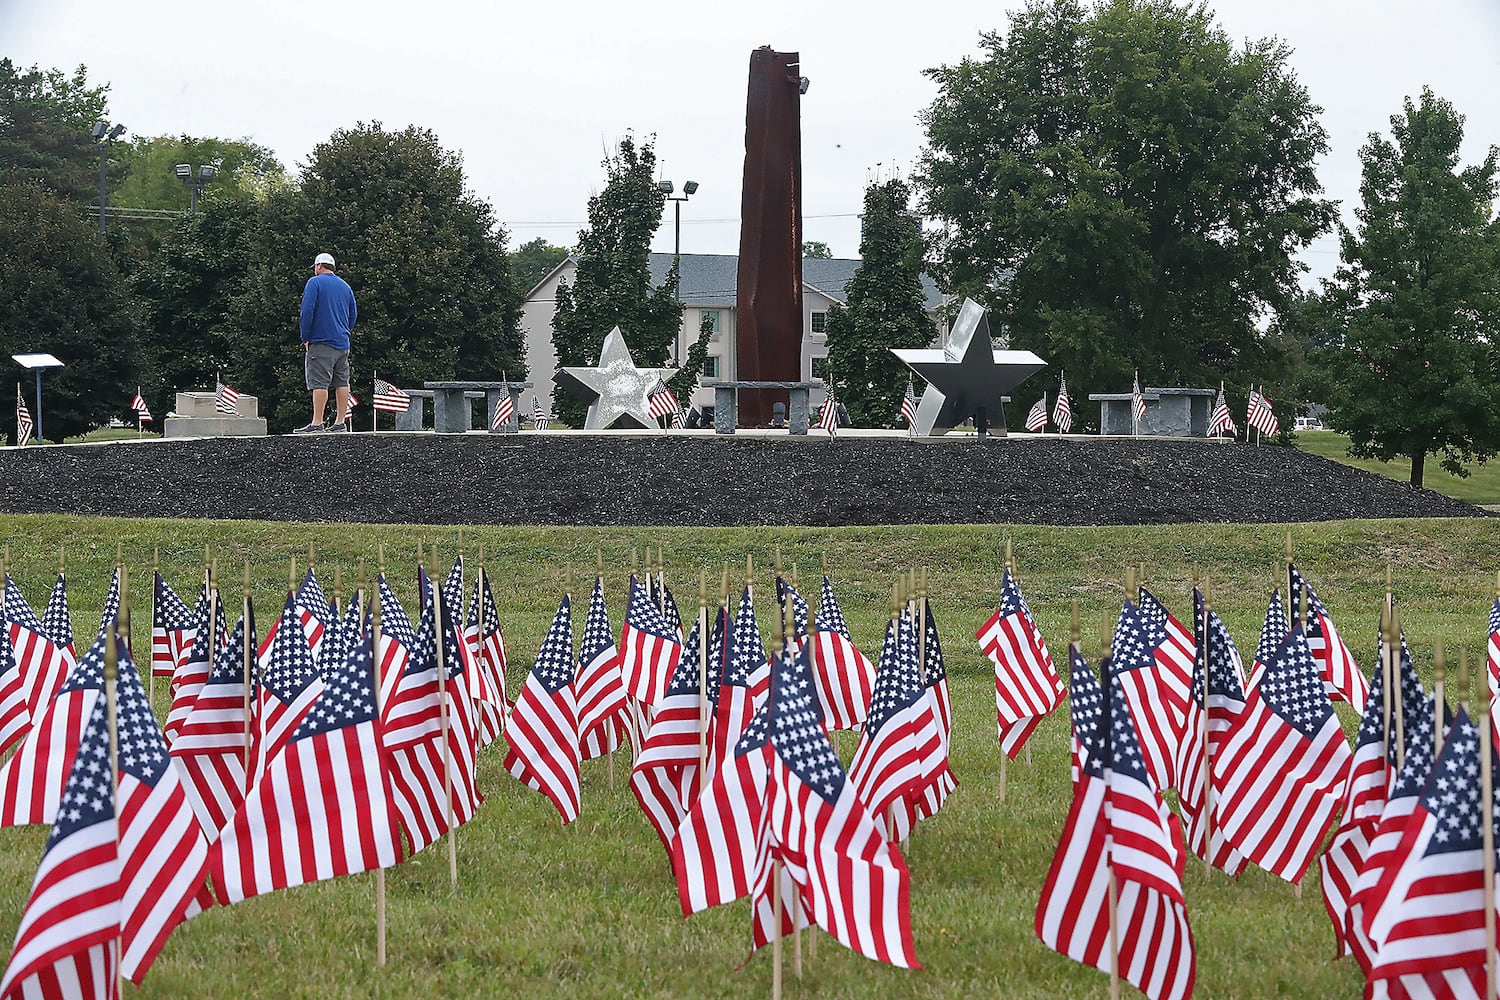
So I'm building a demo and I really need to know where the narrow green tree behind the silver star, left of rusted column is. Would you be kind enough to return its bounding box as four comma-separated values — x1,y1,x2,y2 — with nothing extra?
552,135,683,427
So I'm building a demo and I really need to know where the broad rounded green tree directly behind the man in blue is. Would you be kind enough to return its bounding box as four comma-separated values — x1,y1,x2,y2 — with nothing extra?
217,121,527,429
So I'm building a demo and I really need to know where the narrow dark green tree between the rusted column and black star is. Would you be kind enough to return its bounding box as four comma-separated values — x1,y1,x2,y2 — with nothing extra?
828,178,938,427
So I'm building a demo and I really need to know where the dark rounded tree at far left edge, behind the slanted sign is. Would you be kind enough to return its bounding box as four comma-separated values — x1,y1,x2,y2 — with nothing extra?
0,180,149,441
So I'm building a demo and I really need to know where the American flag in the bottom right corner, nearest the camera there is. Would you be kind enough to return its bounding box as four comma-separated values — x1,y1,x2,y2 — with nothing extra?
1367,709,1493,997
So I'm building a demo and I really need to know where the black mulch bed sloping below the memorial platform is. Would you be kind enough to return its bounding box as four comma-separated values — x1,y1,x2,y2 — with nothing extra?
0,433,1485,526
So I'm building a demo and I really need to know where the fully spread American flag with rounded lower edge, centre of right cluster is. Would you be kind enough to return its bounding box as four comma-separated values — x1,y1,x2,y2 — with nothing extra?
1214,625,1353,882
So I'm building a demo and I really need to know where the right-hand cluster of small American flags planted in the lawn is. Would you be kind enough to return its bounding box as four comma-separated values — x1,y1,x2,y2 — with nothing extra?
977,562,1500,997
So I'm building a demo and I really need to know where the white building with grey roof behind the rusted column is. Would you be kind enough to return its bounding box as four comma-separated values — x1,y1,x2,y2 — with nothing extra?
521,253,944,422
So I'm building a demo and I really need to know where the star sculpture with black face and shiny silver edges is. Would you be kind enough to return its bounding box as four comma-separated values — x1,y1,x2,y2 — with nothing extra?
891,298,1047,438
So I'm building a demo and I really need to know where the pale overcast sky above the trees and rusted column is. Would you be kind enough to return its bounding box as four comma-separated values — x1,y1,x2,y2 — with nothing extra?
0,0,1500,281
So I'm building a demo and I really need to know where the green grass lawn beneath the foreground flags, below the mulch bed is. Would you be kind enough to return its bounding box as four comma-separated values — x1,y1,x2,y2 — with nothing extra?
0,516,1500,999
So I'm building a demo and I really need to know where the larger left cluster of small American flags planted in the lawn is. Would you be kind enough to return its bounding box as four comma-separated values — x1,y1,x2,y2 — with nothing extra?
0,559,956,996
